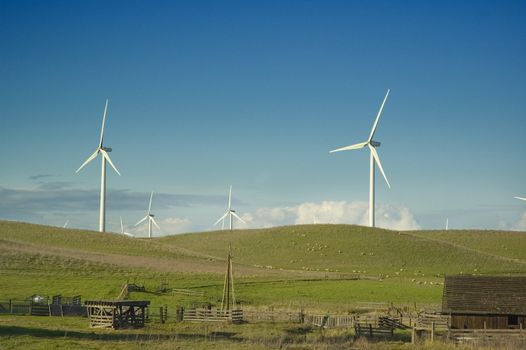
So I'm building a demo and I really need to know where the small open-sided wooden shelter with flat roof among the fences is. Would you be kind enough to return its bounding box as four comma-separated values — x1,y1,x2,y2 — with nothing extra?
85,300,150,329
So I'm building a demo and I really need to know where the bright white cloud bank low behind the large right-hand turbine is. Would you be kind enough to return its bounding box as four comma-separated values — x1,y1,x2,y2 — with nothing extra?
242,201,420,230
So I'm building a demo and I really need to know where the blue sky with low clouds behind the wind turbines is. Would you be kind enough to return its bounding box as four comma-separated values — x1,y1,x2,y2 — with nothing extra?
0,0,526,234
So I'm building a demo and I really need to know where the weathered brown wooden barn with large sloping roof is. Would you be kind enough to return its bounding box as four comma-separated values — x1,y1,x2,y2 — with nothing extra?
442,276,526,329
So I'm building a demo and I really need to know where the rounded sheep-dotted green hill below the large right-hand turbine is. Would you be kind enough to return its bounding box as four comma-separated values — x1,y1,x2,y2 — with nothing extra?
159,225,526,277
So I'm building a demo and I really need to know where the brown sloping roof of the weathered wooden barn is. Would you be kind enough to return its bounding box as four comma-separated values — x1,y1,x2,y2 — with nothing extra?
442,276,526,315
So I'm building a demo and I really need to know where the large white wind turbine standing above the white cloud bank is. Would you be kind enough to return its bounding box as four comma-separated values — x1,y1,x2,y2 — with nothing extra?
330,90,391,227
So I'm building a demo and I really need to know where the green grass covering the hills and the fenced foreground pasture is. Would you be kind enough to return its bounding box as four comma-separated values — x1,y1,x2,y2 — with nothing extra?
0,221,526,349
